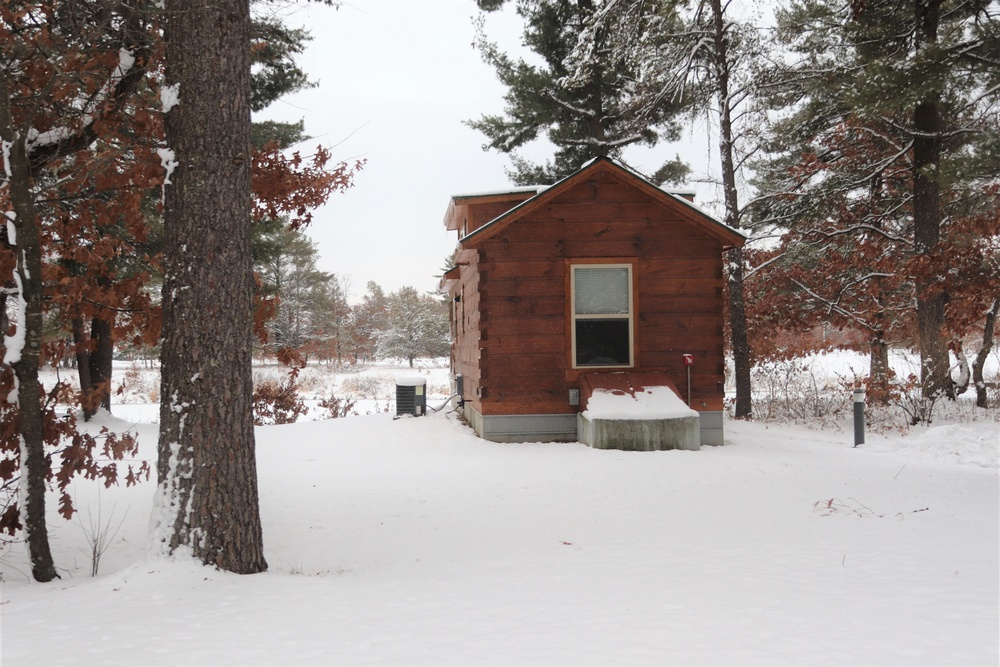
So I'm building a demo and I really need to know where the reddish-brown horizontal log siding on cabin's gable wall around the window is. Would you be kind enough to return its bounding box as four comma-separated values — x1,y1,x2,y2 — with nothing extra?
466,168,724,415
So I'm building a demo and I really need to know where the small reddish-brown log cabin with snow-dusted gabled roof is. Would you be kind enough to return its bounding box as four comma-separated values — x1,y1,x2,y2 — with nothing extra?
441,158,746,450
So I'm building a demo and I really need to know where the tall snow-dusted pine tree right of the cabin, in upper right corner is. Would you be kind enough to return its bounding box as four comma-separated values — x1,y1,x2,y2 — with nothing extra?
760,0,1000,398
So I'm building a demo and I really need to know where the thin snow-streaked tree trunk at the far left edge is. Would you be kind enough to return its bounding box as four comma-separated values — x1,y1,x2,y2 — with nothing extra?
0,76,59,581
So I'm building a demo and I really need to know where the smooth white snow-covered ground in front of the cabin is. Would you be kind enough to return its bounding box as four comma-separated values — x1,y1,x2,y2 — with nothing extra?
0,358,1000,666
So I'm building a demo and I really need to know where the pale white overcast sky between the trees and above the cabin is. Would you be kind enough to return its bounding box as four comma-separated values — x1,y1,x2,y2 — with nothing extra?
255,0,707,299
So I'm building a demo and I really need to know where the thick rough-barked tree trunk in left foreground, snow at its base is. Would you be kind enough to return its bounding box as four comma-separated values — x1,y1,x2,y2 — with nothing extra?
153,0,267,574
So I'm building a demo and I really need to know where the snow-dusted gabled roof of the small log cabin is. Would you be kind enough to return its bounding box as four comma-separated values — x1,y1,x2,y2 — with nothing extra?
445,157,746,248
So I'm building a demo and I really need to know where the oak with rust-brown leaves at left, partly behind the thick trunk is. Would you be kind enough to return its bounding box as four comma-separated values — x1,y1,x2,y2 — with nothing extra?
0,0,360,580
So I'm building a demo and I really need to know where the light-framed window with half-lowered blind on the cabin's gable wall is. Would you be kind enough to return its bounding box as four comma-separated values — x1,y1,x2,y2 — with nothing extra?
571,264,632,368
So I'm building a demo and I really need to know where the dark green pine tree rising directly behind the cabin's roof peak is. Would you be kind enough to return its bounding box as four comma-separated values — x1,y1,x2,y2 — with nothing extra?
468,0,687,185
